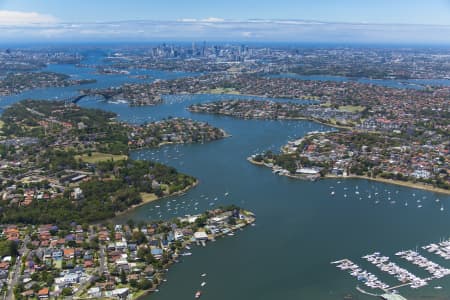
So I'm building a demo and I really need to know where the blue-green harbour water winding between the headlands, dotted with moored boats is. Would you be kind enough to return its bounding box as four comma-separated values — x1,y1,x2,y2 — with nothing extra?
0,50,450,300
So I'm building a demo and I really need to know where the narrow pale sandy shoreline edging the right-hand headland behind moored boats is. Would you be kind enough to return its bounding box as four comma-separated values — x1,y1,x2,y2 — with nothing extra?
247,157,450,195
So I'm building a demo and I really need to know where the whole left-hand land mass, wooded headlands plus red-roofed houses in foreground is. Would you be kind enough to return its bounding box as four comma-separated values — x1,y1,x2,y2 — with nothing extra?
0,100,243,299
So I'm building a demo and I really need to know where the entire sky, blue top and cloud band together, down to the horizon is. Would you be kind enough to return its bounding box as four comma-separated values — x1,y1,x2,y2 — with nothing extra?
0,0,450,44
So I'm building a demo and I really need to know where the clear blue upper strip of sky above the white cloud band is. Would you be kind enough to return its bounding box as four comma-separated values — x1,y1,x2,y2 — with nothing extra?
0,0,450,25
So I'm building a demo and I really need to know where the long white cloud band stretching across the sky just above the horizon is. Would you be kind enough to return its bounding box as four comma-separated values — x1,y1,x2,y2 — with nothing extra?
0,18,450,44
